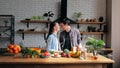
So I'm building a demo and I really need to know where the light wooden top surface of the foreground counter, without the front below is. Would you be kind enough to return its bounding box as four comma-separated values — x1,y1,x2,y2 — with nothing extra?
0,55,114,64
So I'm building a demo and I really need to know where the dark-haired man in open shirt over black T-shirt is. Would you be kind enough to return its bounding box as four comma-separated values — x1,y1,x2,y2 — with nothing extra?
59,20,80,51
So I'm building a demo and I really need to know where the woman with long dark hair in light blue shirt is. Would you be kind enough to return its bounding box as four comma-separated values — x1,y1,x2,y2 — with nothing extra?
46,22,61,51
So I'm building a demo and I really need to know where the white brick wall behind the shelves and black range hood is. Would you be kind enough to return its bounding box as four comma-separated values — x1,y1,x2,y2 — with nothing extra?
0,0,106,47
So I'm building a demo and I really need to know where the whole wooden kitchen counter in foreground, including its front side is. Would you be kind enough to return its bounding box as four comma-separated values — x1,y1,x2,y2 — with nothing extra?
0,55,114,68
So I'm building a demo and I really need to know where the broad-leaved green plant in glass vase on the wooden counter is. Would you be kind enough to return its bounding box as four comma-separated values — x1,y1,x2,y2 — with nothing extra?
86,37,105,56
